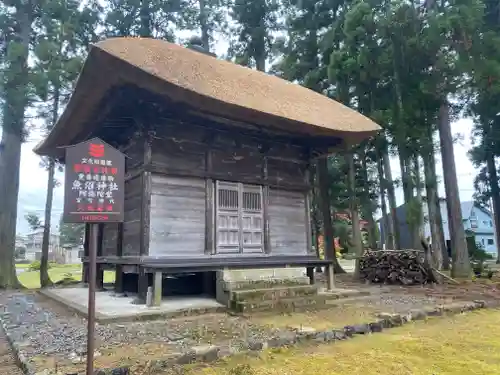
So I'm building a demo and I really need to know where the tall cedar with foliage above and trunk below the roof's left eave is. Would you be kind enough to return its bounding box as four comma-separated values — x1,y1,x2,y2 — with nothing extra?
32,0,98,288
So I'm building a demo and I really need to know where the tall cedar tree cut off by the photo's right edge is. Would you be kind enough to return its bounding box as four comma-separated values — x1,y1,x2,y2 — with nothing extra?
462,0,500,263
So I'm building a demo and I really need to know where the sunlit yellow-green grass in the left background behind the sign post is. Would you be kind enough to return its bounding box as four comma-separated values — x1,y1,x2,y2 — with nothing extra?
16,264,115,289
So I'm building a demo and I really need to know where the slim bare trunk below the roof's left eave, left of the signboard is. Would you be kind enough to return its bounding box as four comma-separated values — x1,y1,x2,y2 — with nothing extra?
40,158,55,288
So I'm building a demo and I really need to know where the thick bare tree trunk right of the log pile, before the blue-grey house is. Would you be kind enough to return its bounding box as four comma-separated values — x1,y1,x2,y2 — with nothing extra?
438,99,470,278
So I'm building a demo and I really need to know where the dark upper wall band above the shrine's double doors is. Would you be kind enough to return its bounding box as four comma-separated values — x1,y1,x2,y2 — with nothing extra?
146,123,308,190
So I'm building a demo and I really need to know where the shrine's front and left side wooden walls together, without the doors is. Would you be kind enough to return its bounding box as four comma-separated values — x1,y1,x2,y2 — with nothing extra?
97,114,310,258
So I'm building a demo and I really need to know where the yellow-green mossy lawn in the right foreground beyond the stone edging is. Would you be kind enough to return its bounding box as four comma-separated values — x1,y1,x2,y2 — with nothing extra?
188,310,500,375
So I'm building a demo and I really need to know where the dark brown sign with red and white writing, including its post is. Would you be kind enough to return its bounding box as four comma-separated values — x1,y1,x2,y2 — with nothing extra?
63,138,125,375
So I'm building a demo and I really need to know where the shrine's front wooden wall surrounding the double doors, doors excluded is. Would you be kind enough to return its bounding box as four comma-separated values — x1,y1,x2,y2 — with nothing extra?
145,119,309,258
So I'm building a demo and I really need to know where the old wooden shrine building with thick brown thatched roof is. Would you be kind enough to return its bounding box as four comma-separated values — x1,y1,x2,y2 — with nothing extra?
35,38,379,308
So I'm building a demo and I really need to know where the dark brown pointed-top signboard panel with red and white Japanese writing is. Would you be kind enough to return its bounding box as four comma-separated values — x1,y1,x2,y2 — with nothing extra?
63,138,125,223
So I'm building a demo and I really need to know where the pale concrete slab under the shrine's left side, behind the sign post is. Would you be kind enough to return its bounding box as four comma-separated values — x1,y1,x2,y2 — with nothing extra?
40,287,226,323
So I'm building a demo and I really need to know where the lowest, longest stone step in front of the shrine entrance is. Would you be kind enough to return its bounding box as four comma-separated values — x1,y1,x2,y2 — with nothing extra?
231,290,370,314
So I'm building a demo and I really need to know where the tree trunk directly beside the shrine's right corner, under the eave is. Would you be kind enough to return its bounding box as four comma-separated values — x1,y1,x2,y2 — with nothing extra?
317,157,345,273
